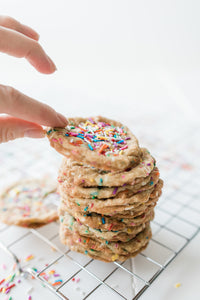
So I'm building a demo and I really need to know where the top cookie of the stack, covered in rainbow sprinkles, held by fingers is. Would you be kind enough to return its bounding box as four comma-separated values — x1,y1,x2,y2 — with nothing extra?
47,116,140,171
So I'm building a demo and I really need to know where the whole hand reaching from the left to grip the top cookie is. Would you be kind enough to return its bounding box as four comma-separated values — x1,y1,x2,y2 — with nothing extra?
0,16,67,143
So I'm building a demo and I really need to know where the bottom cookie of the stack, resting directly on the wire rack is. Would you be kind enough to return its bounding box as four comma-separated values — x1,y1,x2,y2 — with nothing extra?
60,224,152,262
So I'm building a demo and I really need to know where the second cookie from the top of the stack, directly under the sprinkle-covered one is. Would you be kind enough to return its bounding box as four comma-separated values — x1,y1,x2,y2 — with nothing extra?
59,148,155,187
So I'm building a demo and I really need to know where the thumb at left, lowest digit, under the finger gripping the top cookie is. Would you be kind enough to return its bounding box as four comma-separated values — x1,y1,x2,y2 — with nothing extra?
0,116,45,143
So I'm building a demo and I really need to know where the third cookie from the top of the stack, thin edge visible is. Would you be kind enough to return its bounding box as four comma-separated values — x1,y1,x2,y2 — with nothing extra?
59,167,159,199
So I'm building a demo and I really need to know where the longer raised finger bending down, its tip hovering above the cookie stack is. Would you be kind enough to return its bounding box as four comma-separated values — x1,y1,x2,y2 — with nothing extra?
0,27,56,74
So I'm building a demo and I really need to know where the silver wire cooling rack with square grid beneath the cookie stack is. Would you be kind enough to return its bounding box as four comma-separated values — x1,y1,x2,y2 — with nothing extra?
0,115,200,300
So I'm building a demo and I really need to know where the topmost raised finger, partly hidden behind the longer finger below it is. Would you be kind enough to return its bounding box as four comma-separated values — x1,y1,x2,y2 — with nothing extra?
0,16,39,41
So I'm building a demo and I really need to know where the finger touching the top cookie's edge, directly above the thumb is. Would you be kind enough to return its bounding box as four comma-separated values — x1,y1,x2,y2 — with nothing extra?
0,85,68,127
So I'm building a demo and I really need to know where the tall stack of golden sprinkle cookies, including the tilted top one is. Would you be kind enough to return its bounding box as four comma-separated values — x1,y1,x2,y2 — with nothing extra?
47,117,163,262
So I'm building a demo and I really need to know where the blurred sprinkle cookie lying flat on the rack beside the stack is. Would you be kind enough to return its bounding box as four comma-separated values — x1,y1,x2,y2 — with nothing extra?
0,179,60,227
